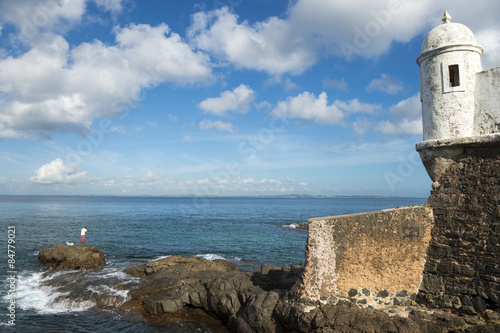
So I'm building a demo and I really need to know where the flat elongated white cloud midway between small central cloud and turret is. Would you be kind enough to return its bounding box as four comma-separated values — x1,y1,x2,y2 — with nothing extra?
271,91,381,125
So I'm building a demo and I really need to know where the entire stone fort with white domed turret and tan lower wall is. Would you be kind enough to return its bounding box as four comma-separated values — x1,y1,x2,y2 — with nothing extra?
295,11,500,314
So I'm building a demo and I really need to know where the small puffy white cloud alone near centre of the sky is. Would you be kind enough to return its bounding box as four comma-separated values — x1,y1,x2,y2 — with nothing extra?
199,84,255,116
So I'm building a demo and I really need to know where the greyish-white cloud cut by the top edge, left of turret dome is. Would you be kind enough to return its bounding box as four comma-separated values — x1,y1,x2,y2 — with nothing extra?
288,0,437,58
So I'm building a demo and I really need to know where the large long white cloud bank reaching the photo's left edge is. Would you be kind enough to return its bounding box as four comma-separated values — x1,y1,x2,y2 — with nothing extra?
0,24,212,139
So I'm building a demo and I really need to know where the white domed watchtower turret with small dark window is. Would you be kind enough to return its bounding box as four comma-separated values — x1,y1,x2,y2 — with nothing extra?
417,11,483,141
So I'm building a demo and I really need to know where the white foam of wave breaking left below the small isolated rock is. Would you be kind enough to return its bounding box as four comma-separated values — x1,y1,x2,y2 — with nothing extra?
17,272,94,314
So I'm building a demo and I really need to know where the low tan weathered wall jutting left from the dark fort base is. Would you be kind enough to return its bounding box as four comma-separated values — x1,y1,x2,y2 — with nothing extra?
300,206,433,305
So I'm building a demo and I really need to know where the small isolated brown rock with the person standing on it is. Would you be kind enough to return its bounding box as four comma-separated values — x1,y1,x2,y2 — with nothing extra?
38,244,106,269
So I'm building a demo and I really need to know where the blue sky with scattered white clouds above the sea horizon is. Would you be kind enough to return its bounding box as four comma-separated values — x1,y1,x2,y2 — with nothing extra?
0,0,500,197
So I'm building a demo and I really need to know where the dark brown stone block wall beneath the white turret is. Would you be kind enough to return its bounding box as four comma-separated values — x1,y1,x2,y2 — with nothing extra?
419,142,500,313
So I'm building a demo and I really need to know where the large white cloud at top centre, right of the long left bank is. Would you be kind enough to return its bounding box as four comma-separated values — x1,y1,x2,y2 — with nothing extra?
188,7,316,75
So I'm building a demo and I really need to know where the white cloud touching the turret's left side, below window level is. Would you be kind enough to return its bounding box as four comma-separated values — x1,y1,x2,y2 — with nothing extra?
375,94,423,135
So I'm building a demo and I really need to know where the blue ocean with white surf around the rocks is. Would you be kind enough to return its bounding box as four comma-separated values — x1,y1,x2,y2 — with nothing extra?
0,196,426,333
